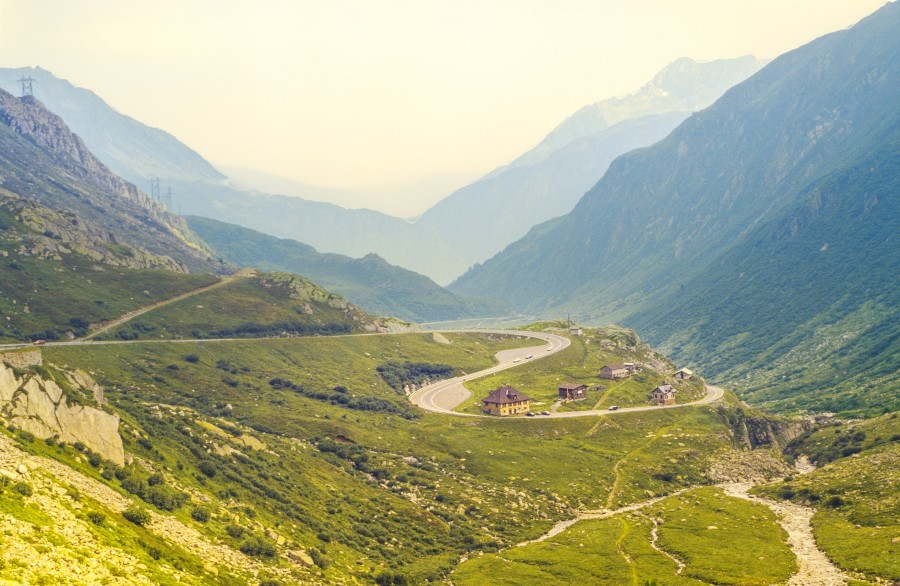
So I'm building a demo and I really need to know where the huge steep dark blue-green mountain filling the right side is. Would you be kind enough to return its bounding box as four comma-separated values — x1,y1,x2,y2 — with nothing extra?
451,3,900,411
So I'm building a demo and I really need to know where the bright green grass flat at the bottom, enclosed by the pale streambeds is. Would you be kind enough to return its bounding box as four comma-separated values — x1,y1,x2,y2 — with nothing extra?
453,488,795,586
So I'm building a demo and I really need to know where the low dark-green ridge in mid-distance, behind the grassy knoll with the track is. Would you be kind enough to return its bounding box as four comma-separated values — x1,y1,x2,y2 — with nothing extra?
188,216,509,322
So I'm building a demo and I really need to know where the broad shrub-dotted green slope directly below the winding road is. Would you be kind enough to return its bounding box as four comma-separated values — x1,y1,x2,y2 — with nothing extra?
37,333,730,582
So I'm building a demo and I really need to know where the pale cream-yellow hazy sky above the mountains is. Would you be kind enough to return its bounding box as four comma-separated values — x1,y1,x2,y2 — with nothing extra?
0,0,884,215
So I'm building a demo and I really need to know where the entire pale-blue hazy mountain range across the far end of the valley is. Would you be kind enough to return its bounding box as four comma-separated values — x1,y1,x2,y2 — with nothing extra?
0,57,761,284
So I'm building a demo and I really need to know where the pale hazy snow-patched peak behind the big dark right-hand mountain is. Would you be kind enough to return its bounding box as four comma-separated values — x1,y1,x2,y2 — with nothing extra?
416,56,762,282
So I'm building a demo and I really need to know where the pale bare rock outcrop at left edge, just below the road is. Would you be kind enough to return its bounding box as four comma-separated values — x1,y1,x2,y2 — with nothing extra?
0,364,125,466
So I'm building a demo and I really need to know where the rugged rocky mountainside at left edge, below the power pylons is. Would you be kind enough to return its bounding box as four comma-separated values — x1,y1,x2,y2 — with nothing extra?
0,90,215,270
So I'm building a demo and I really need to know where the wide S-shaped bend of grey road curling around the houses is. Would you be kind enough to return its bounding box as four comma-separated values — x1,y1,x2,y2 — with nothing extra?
409,330,725,419
